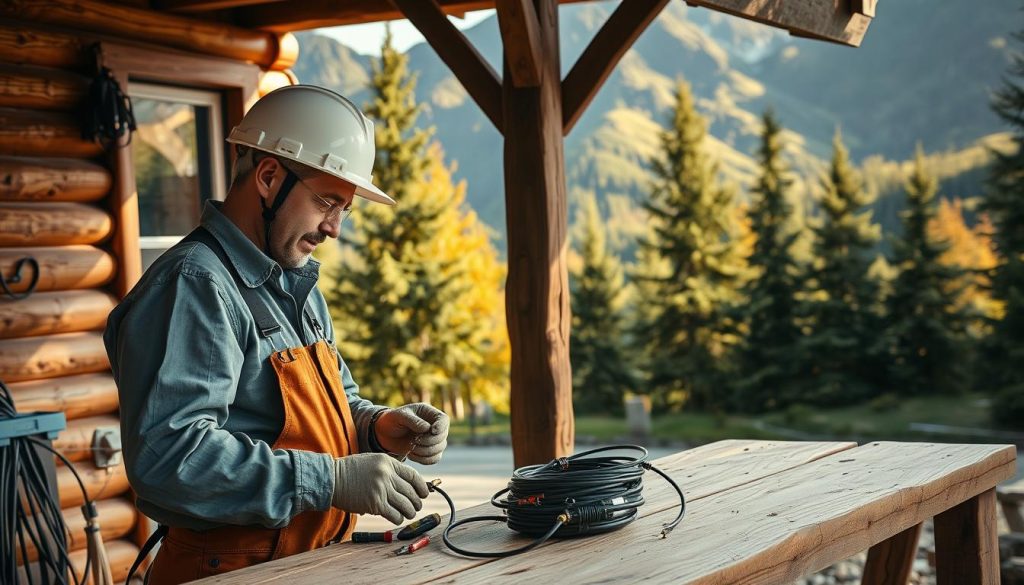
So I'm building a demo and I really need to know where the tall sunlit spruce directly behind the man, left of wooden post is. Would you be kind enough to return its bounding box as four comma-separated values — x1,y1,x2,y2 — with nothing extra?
327,31,457,402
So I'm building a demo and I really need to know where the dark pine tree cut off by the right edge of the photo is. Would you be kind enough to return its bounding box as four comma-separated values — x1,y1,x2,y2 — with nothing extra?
983,28,1024,426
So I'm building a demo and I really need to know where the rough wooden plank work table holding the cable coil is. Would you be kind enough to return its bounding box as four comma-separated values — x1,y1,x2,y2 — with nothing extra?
190,441,1017,585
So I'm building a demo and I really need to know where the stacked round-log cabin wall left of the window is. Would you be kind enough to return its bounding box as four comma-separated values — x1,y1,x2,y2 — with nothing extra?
0,24,133,580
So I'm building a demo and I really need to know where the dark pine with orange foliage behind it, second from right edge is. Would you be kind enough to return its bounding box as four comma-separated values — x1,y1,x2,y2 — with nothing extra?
884,144,966,395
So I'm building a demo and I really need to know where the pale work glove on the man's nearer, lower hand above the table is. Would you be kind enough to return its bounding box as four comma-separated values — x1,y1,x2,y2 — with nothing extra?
331,453,430,525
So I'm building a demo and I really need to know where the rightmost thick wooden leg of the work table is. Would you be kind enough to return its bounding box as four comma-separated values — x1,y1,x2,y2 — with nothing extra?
935,488,999,585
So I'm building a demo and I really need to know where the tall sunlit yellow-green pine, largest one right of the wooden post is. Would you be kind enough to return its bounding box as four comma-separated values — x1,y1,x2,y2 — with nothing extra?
636,82,742,408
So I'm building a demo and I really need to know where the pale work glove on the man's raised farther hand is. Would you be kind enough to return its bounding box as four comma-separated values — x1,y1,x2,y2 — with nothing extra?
372,403,450,465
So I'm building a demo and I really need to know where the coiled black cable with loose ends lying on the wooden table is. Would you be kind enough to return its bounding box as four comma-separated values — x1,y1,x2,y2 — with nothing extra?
428,445,686,558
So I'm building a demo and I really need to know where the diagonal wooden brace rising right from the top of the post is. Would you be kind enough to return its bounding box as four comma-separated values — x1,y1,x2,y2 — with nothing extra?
562,0,669,135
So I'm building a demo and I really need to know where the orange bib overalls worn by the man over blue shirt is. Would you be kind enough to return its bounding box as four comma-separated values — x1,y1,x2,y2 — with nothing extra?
148,340,358,585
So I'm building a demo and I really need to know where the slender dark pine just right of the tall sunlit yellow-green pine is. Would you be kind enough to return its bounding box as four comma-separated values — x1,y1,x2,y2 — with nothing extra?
734,111,801,411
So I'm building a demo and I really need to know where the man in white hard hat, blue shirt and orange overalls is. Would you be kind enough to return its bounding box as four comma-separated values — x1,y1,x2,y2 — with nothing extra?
103,85,449,584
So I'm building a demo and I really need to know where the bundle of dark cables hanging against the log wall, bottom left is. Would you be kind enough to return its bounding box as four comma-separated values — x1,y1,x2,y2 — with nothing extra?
0,380,114,585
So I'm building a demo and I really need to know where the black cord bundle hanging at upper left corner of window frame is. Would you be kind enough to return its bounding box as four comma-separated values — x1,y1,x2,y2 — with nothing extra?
82,43,135,149
